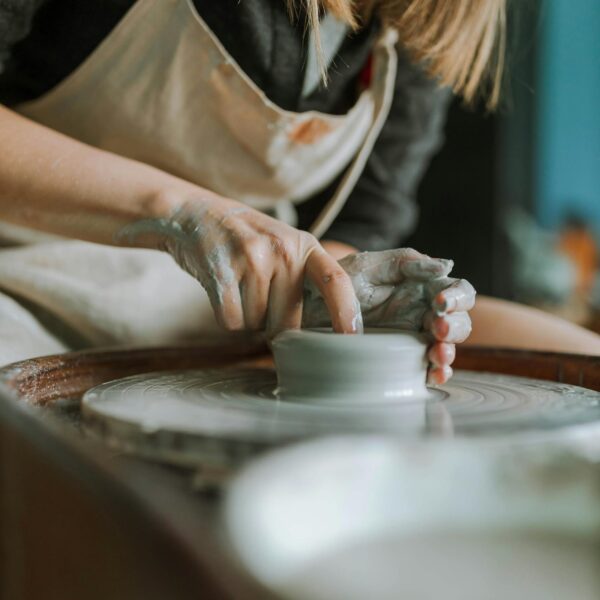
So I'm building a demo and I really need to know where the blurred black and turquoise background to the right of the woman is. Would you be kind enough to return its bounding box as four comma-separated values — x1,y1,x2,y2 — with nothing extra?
404,0,600,332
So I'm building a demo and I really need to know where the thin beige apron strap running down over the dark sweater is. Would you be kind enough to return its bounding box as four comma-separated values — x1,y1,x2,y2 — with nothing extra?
309,29,398,238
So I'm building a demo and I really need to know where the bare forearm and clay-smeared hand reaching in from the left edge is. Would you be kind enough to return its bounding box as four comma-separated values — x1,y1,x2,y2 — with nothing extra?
0,107,361,332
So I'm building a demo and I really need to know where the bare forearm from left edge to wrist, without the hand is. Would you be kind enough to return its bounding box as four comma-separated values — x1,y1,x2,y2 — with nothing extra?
0,106,203,244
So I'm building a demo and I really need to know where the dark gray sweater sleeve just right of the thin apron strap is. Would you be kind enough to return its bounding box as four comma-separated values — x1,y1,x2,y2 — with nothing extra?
298,50,451,250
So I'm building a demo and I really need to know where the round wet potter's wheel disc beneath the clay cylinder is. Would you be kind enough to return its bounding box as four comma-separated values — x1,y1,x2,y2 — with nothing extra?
82,369,600,464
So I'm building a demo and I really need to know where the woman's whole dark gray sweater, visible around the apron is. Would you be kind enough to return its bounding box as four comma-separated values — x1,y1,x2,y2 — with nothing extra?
0,0,449,250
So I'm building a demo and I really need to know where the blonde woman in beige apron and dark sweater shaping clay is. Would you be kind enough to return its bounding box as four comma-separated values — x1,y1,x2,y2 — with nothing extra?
0,0,596,382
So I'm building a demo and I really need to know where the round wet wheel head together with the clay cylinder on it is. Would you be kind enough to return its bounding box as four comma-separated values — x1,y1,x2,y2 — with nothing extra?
82,330,600,466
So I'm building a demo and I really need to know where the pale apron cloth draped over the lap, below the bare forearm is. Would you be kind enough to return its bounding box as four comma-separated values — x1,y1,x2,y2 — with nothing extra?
0,241,219,364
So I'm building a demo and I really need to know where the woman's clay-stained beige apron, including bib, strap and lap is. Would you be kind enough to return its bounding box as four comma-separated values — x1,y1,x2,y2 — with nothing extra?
0,0,396,364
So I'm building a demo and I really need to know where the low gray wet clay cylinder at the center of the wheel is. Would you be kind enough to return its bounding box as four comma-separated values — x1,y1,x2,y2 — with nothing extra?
272,329,428,404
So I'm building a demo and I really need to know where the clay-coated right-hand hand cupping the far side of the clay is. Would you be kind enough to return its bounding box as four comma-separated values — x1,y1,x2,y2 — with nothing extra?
303,248,475,383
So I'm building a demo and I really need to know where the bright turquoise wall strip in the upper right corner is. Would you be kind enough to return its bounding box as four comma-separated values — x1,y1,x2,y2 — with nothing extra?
535,0,600,227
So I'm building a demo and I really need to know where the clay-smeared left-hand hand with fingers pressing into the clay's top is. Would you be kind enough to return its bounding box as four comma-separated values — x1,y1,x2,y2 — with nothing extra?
117,194,362,334
